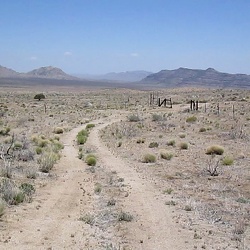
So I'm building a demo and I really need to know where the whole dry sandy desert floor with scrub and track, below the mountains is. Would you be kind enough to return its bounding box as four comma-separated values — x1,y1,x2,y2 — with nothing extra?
0,87,250,250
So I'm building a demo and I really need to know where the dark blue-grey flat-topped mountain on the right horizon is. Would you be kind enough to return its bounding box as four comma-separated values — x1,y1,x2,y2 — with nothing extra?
141,68,250,88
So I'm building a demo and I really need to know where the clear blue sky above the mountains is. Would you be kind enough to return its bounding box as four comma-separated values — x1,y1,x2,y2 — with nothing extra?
0,0,250,74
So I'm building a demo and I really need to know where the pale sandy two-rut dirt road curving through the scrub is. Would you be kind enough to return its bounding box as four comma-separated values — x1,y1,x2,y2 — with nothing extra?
0,114,193,250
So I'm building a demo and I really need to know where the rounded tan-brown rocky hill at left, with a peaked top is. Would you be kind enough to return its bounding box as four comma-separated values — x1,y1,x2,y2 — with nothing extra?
25,66,76,80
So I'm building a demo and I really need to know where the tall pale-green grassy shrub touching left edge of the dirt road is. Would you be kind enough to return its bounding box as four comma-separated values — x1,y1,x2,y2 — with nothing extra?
38,152,60,173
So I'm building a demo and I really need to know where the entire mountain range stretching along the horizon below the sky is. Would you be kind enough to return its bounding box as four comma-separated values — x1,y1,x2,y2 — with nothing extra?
0,66,250,89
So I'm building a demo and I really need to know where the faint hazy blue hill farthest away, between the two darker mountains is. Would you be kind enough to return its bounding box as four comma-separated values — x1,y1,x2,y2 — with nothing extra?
76,70,152,82
